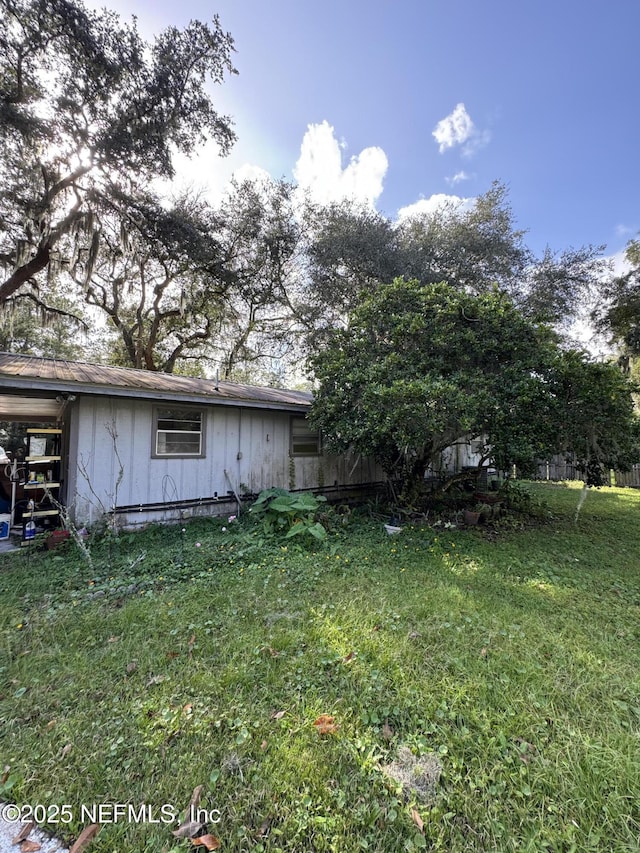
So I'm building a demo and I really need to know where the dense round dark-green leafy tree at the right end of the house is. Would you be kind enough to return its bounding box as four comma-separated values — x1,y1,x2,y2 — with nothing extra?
310,279,634,496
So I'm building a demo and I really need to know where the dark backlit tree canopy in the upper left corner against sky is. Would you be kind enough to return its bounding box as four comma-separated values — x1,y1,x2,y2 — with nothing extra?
0,0,235,304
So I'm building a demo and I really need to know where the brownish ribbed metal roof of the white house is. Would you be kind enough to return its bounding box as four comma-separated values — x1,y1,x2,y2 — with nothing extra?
0,353,312,411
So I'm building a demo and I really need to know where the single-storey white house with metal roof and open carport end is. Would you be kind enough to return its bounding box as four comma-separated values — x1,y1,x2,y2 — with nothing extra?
0,353,383,526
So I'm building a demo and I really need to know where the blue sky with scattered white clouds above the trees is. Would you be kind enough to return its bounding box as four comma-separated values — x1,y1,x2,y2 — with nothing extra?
101,0,640,254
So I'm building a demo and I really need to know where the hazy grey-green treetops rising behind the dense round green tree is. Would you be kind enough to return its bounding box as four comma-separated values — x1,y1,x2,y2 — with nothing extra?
301,182,605,346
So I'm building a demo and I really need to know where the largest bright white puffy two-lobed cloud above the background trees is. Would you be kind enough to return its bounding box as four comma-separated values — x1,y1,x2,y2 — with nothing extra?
293,121,389,207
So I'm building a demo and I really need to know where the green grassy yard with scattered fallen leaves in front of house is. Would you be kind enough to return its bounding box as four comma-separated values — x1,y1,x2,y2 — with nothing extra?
0,485,640,853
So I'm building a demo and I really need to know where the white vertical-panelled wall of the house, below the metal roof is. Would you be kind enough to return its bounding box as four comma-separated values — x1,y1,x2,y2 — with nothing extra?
66,396,383,524
